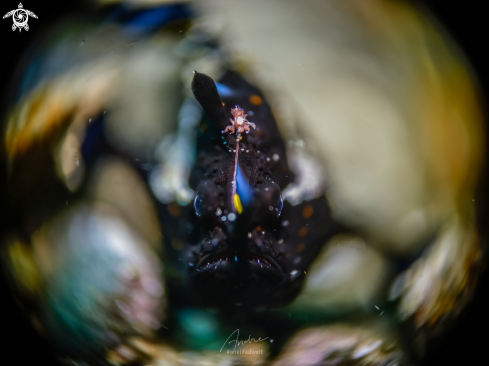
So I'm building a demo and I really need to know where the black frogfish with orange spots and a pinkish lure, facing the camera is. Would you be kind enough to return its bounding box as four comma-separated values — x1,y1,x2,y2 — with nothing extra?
163,71,337,309
